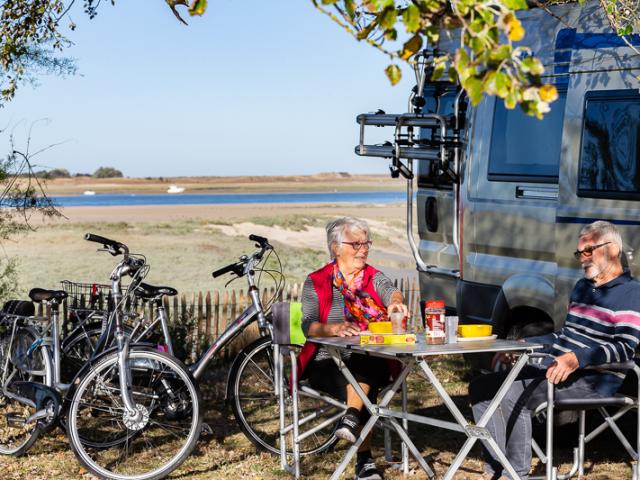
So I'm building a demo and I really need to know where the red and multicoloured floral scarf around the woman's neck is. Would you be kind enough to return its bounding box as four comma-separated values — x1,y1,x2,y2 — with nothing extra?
333,262,387,330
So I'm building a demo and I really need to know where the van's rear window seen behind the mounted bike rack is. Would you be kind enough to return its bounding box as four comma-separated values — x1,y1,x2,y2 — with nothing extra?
416,84,458,189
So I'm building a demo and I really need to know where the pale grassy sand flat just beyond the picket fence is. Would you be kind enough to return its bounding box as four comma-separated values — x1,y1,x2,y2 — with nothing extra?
3,214,411,297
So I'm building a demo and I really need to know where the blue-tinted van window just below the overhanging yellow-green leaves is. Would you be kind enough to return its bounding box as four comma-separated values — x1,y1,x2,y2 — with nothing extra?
488,85,567,183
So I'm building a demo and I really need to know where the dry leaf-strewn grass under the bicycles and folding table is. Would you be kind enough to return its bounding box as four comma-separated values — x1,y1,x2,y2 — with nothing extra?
0,356,630,480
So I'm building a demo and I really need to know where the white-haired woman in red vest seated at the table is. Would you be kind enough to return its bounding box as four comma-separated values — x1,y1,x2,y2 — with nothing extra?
299,217,408,480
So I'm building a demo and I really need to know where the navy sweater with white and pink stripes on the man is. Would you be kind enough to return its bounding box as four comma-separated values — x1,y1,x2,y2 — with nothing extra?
527,271,640,395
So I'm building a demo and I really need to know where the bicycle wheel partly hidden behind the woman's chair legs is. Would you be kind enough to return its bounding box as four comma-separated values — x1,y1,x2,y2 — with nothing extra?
227,337,338,455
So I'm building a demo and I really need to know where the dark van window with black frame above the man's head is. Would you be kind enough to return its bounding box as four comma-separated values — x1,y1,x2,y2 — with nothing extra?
578,90,640,200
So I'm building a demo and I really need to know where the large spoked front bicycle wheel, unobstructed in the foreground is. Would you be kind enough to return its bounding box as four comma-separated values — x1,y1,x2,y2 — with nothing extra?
67,350,202,480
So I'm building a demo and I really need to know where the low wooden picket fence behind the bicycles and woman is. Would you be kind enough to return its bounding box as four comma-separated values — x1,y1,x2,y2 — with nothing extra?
43,278,420,360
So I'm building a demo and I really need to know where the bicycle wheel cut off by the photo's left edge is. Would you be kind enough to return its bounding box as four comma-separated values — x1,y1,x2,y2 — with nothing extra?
0,327,50,456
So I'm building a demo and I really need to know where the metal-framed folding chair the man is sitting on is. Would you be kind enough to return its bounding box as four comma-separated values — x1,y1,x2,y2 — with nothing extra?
529,354,640,480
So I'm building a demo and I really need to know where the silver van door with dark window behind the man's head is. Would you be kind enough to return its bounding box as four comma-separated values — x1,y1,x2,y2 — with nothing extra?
555,31,640,317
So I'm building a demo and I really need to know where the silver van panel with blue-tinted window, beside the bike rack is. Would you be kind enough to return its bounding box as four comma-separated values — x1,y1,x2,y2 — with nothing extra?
458,86,566,334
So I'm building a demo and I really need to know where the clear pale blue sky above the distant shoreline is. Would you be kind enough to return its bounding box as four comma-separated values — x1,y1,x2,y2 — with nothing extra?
0,0,413,177
